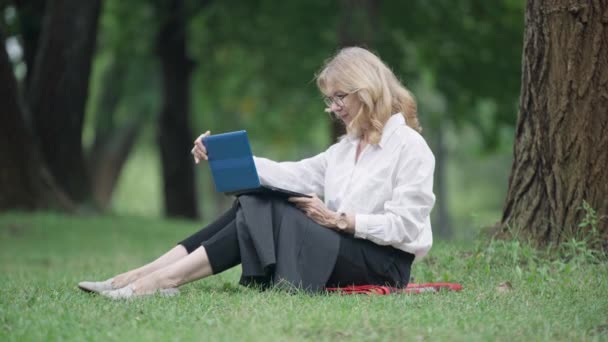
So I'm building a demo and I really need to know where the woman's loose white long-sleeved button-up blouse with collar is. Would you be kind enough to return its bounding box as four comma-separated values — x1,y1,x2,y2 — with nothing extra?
254,113,435,257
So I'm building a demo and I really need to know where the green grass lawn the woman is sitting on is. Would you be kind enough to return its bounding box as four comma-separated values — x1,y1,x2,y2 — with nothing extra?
0,213,608,341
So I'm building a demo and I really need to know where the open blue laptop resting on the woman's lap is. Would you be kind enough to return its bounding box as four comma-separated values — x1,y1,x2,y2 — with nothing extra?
202,131,311,198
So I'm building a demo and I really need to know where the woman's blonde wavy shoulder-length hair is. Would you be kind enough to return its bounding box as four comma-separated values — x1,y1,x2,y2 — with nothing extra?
316,47,422,144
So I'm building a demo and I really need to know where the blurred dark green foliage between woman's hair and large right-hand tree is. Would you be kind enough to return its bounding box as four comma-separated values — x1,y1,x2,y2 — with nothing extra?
379,0,525,149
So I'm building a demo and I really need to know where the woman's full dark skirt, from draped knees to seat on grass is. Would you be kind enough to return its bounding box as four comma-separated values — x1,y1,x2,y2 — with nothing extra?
235,195,414,292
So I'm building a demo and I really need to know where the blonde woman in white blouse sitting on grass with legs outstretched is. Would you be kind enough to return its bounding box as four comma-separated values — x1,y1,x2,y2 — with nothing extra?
79,47,435,299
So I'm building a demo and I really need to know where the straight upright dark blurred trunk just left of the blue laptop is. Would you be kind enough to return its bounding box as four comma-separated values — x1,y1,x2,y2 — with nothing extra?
157,0,198,219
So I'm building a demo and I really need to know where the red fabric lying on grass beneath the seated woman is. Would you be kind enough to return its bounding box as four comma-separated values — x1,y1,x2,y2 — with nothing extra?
326,283,462,295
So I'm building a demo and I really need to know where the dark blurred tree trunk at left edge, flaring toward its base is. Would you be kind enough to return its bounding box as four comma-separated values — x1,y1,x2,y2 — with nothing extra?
0,32,72,210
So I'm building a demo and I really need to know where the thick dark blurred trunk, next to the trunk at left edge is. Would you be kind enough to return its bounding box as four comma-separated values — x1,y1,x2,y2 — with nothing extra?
29,0,100,203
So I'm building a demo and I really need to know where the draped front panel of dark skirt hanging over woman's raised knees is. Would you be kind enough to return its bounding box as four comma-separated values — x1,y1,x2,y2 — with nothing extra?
236,195,340,291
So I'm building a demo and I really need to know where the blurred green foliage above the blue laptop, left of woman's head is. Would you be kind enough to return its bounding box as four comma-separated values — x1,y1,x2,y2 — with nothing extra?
190,0,335,158
